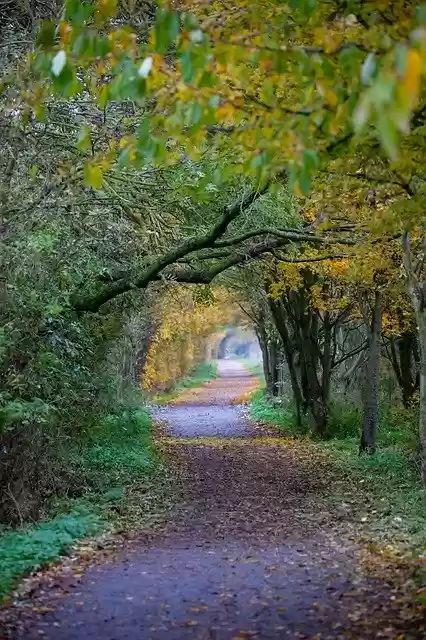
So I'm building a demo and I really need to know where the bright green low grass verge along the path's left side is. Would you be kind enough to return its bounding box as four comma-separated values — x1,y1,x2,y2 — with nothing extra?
0,408,159,597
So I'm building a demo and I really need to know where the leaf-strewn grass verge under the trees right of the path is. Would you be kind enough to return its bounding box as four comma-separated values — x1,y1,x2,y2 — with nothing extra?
250,390,426,546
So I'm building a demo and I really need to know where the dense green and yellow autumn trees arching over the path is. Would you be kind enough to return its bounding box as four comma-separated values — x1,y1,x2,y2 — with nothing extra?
0,0,426,540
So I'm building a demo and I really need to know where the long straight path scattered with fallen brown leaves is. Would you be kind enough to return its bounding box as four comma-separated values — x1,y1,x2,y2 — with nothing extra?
0,361,426,640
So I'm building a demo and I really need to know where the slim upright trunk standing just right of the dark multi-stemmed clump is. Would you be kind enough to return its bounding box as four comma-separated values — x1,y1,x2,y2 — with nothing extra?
359,291,382,455
